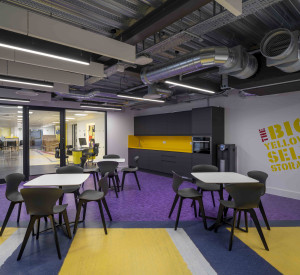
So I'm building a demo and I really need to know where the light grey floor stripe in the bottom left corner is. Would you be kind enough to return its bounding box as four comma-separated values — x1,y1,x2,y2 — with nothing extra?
0,228,26,266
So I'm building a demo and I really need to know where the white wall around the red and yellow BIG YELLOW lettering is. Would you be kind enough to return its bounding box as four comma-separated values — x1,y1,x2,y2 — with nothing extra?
135,92,300,199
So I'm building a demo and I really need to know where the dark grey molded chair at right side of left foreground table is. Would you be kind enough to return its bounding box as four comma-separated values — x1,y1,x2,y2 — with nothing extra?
73,173,112,234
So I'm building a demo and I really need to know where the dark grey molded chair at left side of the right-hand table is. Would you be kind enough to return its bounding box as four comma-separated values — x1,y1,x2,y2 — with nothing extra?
169,172,207,230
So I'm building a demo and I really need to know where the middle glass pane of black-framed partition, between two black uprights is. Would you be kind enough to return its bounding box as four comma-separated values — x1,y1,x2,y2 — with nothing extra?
28,109,66,175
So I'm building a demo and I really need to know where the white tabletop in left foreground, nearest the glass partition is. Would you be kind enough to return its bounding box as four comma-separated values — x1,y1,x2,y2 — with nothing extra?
24,174,90,186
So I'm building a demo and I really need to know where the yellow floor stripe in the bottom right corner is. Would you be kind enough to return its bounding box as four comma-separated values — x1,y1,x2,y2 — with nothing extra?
233,227,300,275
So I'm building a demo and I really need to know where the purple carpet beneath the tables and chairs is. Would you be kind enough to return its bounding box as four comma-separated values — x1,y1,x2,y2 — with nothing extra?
0,172,300,224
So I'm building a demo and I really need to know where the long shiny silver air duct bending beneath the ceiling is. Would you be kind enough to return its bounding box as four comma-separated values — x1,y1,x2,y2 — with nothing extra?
141,46,257,84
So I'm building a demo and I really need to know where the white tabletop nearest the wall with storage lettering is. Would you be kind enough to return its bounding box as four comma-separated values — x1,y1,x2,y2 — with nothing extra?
192,172,258,184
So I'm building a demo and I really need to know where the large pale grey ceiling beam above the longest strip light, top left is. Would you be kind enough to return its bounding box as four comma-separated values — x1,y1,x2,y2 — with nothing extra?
0,3,136,63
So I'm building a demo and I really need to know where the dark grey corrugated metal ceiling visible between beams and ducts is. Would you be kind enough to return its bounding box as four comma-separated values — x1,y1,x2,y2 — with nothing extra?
2,0,300,100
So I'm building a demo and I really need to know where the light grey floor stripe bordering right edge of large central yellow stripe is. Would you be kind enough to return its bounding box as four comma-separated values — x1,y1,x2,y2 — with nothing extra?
166,228,217,275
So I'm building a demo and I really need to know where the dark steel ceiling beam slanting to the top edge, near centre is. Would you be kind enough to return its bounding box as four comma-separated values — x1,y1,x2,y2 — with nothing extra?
118,0,211,45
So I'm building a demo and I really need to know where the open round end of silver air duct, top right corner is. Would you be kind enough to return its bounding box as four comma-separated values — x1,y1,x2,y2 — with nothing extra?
260,29,300,73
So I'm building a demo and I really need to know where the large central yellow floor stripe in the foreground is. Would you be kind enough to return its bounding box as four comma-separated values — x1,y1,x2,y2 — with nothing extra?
60,228,191,275
